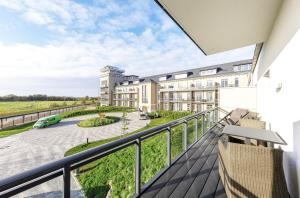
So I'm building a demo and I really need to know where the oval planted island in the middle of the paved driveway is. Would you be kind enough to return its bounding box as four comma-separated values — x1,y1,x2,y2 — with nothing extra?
77,116,120,127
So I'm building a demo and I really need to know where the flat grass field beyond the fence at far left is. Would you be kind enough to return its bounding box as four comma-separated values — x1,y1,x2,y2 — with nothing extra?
0,101,80,116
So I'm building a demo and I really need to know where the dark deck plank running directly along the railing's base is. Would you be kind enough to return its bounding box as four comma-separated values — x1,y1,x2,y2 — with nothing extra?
141,133,214,198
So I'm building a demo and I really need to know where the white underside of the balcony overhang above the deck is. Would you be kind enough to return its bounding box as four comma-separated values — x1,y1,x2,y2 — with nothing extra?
156,0,282,55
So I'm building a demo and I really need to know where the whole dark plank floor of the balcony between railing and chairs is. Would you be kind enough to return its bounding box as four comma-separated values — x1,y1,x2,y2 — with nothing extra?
141,126,227,198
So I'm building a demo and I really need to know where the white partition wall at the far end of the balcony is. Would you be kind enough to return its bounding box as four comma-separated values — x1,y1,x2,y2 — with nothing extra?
219,87,257,112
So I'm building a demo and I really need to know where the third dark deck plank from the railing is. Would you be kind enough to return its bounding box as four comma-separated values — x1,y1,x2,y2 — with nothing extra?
170,133,218,198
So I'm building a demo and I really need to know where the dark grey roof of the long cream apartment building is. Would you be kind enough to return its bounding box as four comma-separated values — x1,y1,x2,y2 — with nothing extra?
117,59,252,85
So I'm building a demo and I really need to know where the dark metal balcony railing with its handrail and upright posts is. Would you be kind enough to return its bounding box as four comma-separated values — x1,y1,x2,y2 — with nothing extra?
0,107,225,197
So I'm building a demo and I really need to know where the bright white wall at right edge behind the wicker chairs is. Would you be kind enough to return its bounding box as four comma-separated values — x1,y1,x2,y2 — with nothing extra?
253,0,300,197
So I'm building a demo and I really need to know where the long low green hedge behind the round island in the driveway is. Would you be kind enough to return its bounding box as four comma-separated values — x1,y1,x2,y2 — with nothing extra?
60,106,134,118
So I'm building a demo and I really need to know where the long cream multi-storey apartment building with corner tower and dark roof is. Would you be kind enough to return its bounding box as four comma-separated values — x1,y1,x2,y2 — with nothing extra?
100,60,252,112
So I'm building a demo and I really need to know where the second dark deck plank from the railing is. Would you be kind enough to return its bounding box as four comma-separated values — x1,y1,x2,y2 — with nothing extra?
155,131,216,197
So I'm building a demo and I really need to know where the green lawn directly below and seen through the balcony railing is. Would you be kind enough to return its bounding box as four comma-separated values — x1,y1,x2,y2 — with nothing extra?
65,112,201,197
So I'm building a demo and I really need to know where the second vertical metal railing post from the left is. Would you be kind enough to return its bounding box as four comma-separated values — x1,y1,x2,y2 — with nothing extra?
135,139,141,196
